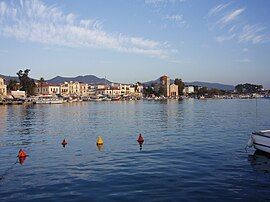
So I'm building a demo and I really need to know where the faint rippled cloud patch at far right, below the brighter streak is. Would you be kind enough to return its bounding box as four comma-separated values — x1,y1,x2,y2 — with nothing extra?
239,25,266,44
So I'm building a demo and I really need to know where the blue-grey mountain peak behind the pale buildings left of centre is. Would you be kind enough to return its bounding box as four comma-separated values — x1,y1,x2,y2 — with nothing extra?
46,75,112,84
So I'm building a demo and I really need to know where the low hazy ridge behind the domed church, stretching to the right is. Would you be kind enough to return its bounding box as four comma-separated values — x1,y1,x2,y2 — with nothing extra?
144,78,234,91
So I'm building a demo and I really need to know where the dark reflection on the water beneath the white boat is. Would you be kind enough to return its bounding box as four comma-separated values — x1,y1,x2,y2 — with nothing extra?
248,150,270,173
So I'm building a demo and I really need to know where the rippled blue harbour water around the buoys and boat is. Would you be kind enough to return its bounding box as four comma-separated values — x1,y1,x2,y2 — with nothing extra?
0,99,270,201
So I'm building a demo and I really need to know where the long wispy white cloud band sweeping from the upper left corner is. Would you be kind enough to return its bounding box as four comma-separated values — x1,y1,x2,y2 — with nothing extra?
0,0,175,58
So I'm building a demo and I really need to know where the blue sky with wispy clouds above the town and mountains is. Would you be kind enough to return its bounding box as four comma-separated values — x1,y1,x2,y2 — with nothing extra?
0,0,270,88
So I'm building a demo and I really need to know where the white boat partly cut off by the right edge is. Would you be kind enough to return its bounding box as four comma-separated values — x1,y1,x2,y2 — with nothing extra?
247,130,270,153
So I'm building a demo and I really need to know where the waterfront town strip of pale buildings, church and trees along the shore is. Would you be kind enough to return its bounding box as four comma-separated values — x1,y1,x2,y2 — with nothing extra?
0,70,269,104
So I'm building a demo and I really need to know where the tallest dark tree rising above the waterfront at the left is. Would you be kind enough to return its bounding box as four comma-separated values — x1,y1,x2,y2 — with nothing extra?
17,69,36,96
